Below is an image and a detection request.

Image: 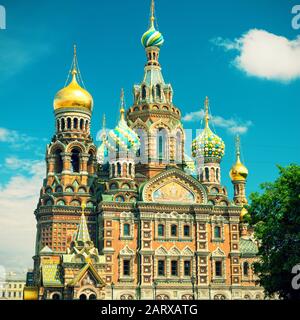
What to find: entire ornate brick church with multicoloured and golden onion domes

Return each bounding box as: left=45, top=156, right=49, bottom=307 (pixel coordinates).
left=25, top=1, right=263, bottom=300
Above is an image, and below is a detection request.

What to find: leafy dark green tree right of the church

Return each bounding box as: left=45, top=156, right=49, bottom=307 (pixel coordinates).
left=248, top=164, right=300, bottom=299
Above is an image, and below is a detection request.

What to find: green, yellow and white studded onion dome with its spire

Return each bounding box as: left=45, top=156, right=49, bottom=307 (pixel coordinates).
left=192, top=97, right=225, bottom=161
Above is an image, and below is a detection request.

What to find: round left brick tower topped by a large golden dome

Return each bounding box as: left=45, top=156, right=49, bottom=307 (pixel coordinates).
left=35, top=46, right=97, bottom=256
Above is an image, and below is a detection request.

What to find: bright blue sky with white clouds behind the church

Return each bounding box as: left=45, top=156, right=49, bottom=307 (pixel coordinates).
left=0, top=0, right=300, bottom=268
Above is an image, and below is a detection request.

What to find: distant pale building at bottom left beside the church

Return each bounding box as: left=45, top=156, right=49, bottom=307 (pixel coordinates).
left=0, top=274, right=25, bottom=300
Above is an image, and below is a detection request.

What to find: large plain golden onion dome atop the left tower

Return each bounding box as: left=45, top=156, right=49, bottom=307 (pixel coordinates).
left=53, top=68, right=93, bottom=111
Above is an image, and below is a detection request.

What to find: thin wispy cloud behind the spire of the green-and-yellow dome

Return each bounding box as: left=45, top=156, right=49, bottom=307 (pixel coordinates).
left=182, top=109, right=252, bottom=134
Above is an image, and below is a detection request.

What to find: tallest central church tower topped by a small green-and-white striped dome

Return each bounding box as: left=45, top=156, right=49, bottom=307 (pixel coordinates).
left=127, top=0, right=184, bottom=178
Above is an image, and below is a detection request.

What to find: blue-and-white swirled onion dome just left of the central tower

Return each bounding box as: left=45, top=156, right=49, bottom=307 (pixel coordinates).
left=107, top=90, right=140, bottom=152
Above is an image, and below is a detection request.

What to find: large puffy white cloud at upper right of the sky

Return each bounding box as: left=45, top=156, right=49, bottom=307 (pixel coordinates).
left=212, top=29, right=300, bottom=82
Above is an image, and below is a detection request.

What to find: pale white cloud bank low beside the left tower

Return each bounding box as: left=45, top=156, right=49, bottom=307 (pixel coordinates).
left=0, top=158, right=45, bottom=269
